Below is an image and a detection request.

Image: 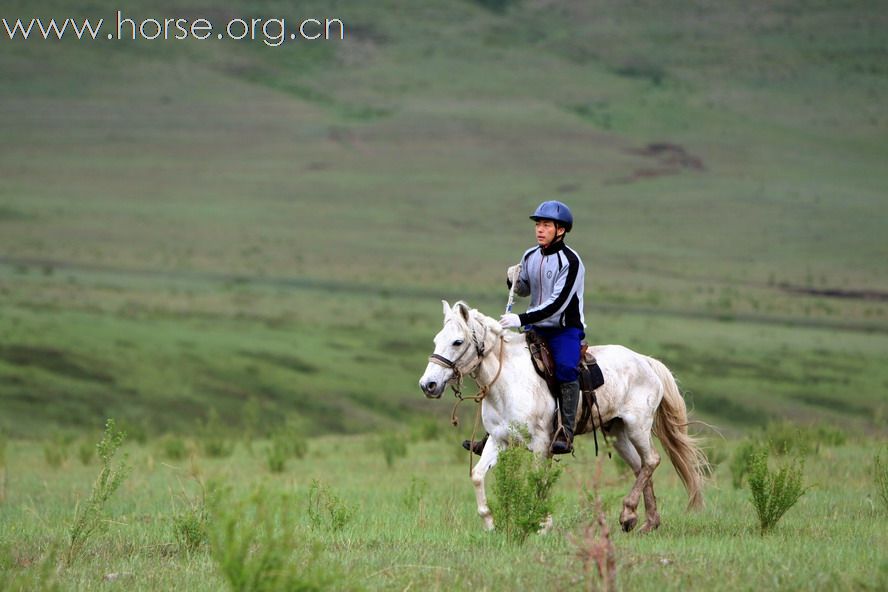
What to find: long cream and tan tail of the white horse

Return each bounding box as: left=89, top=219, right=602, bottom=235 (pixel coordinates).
left=648, top=357, right=709, bottom=510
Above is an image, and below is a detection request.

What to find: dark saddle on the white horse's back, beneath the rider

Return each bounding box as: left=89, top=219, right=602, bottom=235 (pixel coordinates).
left=525, top=331, right=604, bottom=442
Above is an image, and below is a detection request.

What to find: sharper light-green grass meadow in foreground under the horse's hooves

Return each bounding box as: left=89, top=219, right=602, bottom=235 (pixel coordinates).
left=0, top=434, right=888, bottom=590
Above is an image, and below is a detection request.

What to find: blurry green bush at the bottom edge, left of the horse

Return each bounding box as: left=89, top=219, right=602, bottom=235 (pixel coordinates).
left=209, top=489, right=349, bottom=592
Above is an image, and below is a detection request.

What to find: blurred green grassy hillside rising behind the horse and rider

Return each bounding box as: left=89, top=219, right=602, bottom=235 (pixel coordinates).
left=0, top=0, right=888, bottom=435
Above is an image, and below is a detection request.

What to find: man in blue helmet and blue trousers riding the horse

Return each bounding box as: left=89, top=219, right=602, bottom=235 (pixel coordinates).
left=463, top=201, right=586, bottom=454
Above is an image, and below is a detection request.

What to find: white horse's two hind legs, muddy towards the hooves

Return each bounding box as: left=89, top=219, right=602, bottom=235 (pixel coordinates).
left=618, top=418, right=660, bottom=532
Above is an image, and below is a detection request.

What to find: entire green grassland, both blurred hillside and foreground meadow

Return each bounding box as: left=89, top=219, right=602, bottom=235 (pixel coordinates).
left=0, top=0, right=888, bottom=590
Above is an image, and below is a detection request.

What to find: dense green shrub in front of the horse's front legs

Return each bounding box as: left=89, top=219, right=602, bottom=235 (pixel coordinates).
left=491, top=438, right=561, bottom=544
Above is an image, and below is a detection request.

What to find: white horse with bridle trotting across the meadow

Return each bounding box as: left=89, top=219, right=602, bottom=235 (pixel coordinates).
left=419, top=301, right=708, bottom=532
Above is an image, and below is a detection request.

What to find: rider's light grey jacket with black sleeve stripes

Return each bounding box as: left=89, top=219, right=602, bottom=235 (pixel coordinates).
left=506, top=241, right=586, bottom=330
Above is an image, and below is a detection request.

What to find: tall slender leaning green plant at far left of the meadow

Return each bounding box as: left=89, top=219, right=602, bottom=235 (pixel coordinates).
left=65, top=419, right=130, bottom=565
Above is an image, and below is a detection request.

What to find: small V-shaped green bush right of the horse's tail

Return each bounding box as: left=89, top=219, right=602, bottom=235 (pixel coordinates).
left=749, top=448, right=807, bottom=535
